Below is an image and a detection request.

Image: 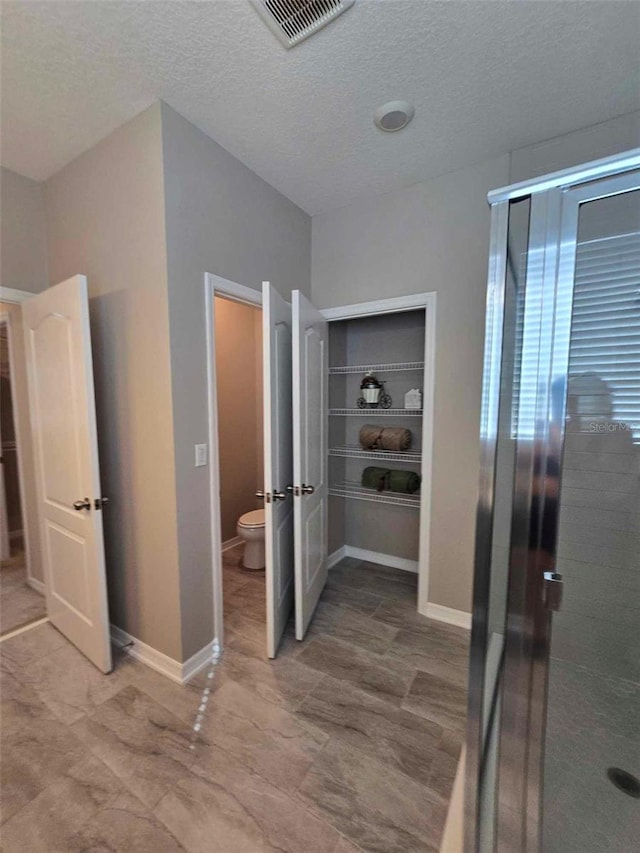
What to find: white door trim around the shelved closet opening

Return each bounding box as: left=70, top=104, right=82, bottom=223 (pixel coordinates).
left=320, top=291, right=437, bottom=616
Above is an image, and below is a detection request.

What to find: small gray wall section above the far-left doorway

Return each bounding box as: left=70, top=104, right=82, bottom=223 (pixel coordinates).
left=0, top=167, right=47, bottom=293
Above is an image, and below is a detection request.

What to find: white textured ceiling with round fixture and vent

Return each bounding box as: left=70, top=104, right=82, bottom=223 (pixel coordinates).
left=1, top=0, right=640, bottom=214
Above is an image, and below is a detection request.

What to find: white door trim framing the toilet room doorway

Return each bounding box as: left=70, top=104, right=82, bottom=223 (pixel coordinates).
left=204, top=272, right=262, bottom=649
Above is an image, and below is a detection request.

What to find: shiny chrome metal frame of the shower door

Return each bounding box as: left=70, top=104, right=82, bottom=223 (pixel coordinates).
left=465, top=149, right=640, bottom=853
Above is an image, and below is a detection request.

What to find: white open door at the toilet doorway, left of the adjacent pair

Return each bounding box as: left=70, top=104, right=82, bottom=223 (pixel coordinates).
left=262, top=282, right=293, bottom=658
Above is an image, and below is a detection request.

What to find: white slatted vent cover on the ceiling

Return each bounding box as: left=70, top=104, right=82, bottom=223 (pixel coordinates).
left=250, top=0, right=356, bottom=47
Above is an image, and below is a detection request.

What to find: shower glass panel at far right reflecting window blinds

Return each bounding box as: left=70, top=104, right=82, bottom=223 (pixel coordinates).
left=542, top=191, right=640, bottom=853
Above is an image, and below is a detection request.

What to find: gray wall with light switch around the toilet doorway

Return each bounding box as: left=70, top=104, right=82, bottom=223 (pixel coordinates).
left=162, top=104, right=311, bottom=657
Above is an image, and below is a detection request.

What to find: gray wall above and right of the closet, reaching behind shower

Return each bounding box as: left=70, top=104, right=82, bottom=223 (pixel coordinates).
left=311, top=113, right=640, bottom=610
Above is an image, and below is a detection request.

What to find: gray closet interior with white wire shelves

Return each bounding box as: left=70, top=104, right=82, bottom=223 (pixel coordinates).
left=328, top=311, right=425, bottom=565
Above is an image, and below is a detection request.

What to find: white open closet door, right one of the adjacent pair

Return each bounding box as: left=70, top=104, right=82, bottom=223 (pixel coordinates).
left=292, top=290, right=329, bottom=640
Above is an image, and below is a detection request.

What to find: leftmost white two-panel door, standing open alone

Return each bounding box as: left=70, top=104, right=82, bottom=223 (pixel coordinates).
left=22, top=275, right=111, bottom=672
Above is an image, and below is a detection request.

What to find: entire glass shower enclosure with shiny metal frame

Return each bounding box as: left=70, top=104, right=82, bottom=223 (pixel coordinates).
left=465, top=150, right=640, bottom=853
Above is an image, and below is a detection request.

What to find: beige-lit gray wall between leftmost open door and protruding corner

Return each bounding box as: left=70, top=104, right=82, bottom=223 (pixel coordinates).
left=45, top=104, right=184, bottom=660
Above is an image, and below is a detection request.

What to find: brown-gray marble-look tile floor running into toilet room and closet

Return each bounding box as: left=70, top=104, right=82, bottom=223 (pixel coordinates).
left=0, top=550, right=467, bottom=853
